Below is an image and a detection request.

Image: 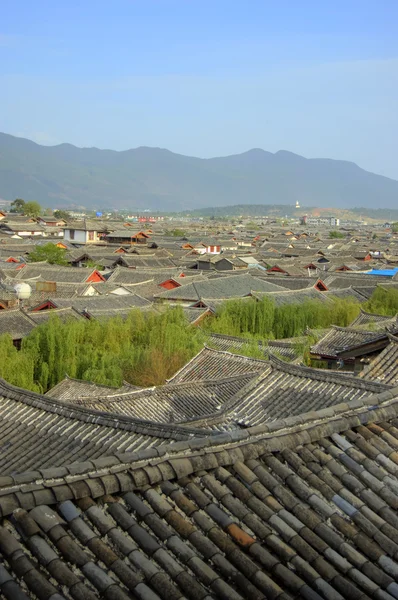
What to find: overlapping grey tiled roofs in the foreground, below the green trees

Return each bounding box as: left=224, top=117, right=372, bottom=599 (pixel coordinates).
left=0, top=336, right=398, bottom=600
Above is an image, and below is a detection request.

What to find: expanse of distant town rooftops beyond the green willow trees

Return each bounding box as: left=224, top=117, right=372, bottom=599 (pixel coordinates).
left=0, top=215, right=398, bottom=343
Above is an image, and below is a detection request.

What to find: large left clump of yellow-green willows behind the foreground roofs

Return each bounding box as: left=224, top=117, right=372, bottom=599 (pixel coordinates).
left=0, top=308, right=204, bottom=392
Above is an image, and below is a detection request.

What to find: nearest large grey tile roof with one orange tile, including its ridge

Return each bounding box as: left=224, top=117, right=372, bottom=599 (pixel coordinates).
left=0, top=390, right=398, bottom=600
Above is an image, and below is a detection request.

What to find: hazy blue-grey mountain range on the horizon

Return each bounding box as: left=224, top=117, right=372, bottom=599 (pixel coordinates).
left=0, top=133, right=398, bottom=212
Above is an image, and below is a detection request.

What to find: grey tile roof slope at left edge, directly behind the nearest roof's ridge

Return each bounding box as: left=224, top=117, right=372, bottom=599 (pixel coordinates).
left=0, top=380, right=211, bottom=474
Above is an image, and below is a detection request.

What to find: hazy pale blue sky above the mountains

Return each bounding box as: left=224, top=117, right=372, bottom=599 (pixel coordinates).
left=0, top=0, right=398, bottom=179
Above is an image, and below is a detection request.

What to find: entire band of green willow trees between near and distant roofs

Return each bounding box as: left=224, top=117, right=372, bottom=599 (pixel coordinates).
left=0, top=287, right=398, bottom=392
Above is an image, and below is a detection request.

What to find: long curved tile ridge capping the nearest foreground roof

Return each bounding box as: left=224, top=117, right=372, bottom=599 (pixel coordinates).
left=0, top=387, right=398, bottom=516
